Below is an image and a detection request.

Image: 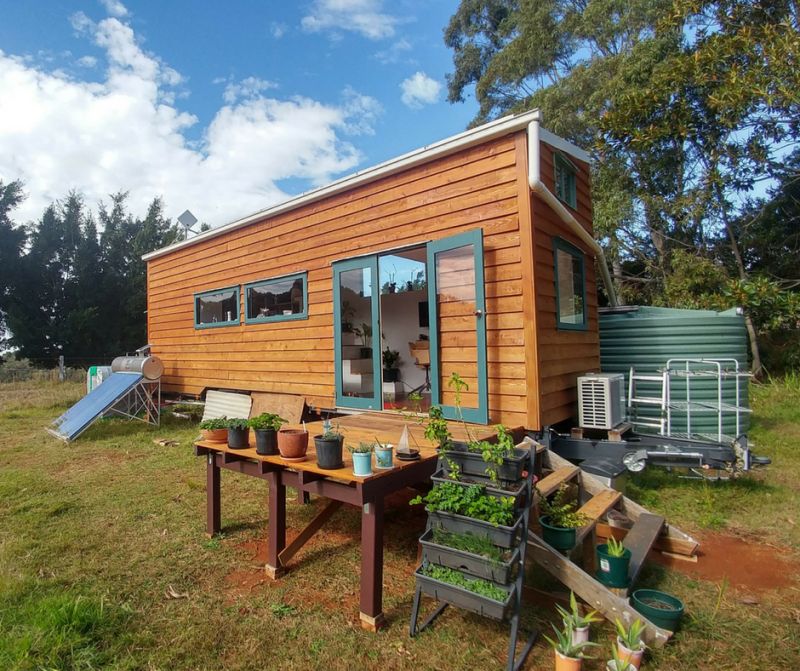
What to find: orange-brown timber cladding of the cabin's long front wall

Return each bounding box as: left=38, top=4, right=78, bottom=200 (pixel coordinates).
left=148, top=135, right=535, bottom=425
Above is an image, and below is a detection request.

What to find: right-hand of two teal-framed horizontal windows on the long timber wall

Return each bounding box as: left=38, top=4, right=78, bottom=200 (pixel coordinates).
left=244, top=273, right=308, bottom=323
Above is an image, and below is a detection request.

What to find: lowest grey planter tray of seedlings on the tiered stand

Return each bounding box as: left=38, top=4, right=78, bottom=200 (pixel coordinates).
left=414, top=564, right=516, bottom=620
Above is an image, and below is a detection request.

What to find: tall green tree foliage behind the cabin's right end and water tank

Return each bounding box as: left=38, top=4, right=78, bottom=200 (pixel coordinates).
left=445, top=0, right=800, bottom=371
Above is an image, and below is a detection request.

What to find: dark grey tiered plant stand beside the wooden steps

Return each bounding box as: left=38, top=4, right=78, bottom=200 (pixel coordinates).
left=409, top=440, right=537, bottom=671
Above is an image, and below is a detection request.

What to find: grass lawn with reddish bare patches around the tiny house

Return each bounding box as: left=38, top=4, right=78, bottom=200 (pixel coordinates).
left=0, top=383, right=800, bottom=671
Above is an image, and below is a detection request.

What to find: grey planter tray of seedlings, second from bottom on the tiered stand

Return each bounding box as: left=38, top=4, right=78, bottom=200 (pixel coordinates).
left=419, top=527, right=519, bottom=585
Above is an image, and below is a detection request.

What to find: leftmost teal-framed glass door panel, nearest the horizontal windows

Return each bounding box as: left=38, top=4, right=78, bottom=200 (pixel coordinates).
left=333, top=256, right=381, bottom=410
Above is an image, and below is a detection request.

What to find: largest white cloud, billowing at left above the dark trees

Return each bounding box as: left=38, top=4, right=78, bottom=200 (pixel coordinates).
left=0, top=18, right=380, bottom=225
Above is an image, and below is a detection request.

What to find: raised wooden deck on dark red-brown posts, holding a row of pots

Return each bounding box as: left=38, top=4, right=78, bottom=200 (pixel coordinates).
left=195, top=413, right=494, bottom=631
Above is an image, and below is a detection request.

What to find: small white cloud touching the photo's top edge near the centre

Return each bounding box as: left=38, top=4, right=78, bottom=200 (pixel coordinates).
left=301, top=0, right=400, bottom=40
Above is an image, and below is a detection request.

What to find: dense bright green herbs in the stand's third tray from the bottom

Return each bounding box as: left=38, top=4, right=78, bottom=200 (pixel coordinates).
left=409, top=482, right=514, bottom=526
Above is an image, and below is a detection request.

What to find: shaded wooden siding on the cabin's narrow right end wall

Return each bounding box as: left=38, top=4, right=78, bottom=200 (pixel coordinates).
left=528, top=143, right=600, bottom=429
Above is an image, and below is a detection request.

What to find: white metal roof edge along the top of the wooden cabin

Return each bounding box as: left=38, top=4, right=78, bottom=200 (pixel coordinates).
left=142, top=110, right=589, bottom=261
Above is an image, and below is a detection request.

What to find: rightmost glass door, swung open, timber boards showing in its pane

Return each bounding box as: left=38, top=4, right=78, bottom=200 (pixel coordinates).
left=428, top=230, right=489, bottom=423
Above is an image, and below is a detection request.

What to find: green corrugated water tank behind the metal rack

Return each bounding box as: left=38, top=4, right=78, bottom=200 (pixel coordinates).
left=600, top=306, right=750, bottom=439
